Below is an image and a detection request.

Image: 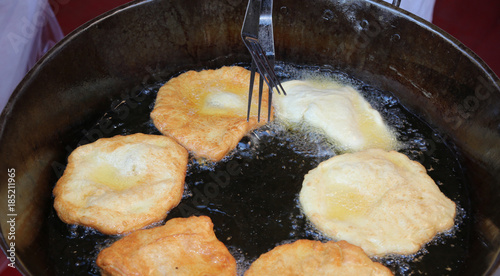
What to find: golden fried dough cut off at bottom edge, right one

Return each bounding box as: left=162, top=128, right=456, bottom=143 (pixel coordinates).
left=245, top=240, right=392, bottom=276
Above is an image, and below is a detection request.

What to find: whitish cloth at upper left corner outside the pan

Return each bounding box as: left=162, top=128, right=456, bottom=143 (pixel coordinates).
left=0, top=0, right=63, bottom=111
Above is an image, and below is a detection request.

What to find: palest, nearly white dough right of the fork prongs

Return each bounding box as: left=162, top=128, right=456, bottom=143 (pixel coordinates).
left=274, top=80, right=398, bottom=151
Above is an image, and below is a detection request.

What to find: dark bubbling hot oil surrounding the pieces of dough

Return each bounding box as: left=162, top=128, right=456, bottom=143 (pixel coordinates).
left=45, top=64, right=470, bottom=275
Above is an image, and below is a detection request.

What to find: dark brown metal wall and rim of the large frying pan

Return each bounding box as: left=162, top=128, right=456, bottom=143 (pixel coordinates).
left=0, top=0, right=500, bottom=275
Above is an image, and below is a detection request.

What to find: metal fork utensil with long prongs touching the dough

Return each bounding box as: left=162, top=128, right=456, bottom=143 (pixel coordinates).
left=241, top=0, right=286, bottom=122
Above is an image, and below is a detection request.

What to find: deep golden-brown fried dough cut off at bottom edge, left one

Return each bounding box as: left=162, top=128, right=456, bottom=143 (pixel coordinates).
left=97, top=216, right=236, bottom=276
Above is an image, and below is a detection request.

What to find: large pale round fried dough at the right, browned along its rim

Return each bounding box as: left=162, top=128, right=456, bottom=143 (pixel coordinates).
left=300, top=149, right=456, bottom=256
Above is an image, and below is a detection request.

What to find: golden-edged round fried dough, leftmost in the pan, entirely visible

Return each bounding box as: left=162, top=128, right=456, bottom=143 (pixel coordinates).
left=53, top=134, right=188, bottom=235
